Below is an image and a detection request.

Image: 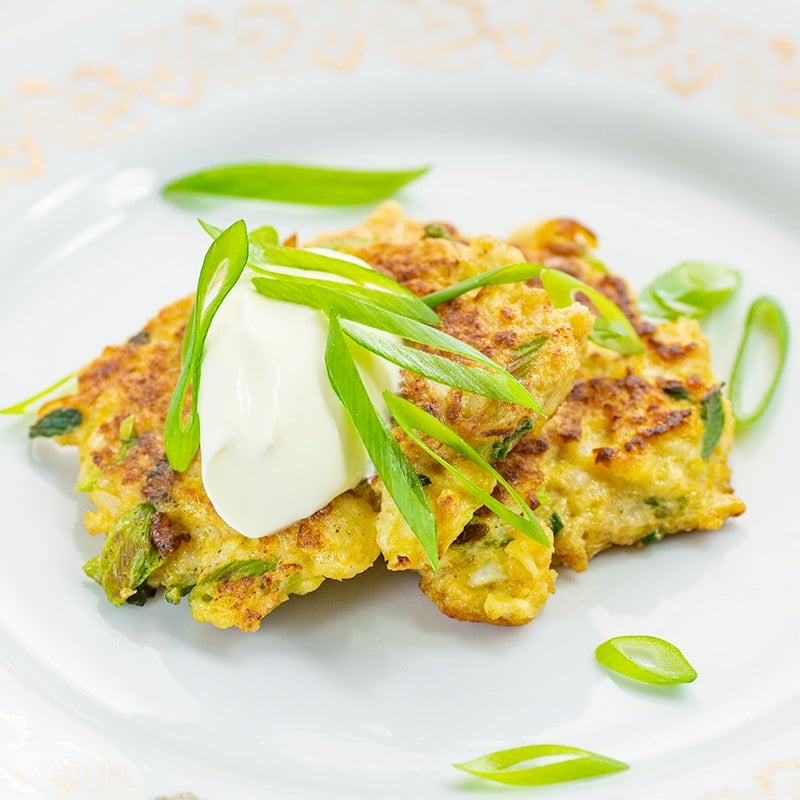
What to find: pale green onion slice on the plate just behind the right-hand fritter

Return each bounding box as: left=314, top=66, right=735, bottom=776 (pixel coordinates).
left=639, top=261, right=741, bottom=320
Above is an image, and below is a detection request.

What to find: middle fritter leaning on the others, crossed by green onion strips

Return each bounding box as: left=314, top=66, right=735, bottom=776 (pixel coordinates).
left=315, top=203, right=593, bottom=580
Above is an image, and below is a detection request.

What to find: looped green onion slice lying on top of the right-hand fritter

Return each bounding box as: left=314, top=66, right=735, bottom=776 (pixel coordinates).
left=539, top=269, right=644, bottom=356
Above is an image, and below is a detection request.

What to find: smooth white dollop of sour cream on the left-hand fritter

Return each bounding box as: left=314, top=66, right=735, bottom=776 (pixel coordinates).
left=198, top=251, right=399, bottom=538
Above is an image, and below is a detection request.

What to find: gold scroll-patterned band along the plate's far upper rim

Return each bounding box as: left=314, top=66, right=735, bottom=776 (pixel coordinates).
left=0, top=0, right=800, bottom=188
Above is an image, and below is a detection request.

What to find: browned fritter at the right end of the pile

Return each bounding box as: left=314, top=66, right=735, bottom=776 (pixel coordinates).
left=511, top=220, right=744, bottom=570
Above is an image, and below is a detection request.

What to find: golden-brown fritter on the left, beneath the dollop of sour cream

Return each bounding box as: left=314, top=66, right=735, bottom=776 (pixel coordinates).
left=41, top=298, right=378, bottom=630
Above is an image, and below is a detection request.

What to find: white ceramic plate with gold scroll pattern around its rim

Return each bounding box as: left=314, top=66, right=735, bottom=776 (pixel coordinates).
left=0, top=0, right=800, bottom=800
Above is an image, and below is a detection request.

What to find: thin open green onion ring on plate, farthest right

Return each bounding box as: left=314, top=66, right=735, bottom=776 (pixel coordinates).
left=728, top=297, right=789, bottom=425
